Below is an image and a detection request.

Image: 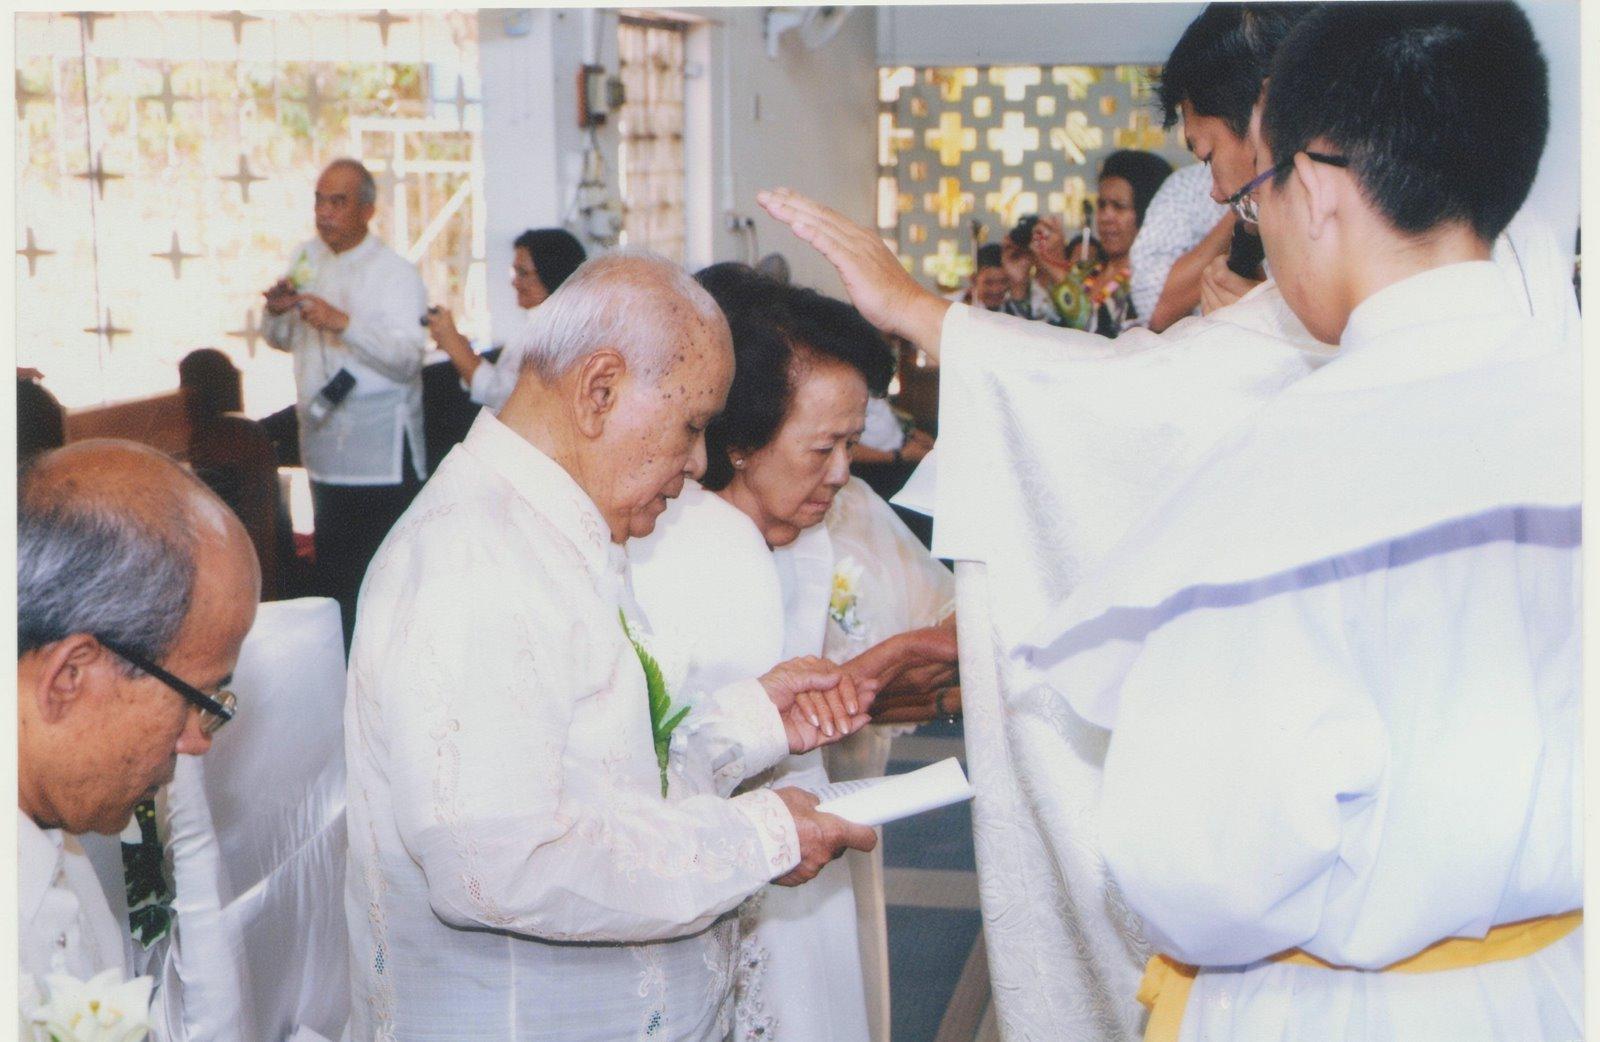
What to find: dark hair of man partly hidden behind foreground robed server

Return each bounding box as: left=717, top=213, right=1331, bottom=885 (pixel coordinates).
left=1157, top=3, right=1314, bottom=138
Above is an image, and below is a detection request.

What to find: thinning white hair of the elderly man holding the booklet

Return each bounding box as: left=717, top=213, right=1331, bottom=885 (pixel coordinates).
left=507, top=250, right=731, bottom=381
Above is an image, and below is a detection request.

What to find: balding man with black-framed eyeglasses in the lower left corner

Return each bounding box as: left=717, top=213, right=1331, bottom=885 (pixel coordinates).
left=16, top=440, right=261, bottom=1024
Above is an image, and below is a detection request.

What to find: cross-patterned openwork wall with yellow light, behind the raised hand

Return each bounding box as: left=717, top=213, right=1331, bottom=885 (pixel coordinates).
left=878, top=66, right=1194, bottom=288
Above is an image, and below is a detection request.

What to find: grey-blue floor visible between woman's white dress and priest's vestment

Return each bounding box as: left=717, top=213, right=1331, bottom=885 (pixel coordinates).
left=883, top=723, right=994, bottom=1042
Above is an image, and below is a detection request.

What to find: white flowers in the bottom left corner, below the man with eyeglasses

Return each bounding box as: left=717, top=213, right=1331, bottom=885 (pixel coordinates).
left=21, top=970, right=155, bottom=1042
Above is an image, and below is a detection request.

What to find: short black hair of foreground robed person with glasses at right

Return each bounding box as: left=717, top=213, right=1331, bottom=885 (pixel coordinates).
left=1261, top=0, right=1550, bottom=242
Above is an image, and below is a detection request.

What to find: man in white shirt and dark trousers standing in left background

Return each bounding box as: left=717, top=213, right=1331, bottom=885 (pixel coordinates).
left=264, top=158, right=427, bottom=642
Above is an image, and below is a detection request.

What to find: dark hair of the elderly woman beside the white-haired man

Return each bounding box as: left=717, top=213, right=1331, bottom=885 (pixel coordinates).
left=694, top=264, right=894, bottom=491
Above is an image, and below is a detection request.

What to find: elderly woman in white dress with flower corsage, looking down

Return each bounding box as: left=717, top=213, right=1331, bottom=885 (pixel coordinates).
left=629, top=266, right=958, bottom=1042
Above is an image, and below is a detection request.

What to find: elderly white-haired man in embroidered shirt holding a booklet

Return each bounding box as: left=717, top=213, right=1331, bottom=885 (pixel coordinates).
left=346, top=254, right=875, bottom=1042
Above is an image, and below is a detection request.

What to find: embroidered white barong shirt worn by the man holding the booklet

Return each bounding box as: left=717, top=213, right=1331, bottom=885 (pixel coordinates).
left=346, top=411, right=798, bottom=1042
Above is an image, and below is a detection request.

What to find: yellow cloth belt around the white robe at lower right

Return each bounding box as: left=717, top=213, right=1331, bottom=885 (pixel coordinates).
left=1139, top=908, right=1584, bottom=1042
